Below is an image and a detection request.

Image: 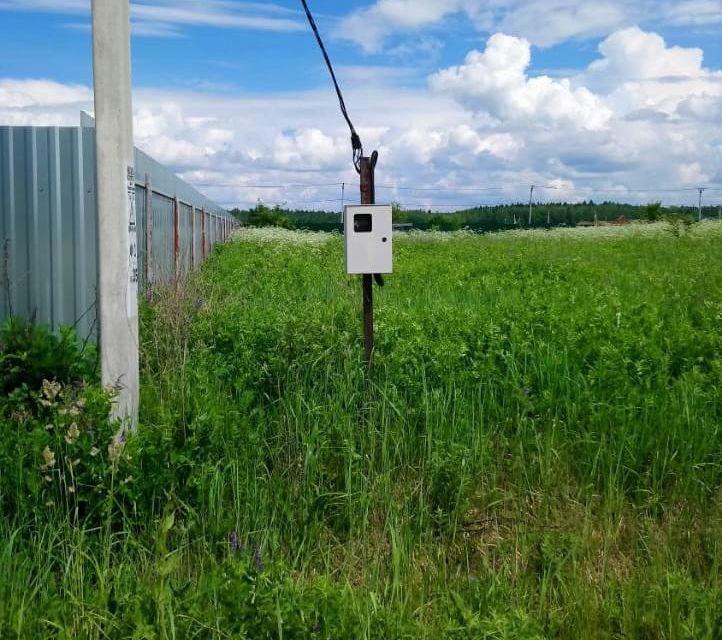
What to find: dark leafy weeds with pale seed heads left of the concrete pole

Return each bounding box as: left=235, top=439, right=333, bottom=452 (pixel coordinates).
left=0, top=320, right=130, bottom=522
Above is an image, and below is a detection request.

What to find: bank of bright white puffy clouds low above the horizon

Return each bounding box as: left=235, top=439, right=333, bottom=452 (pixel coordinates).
left=0, top=27, right=722, bottom=209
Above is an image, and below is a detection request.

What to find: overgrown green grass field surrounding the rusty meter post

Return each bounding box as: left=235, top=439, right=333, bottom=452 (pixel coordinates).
left=0, top=223, right=722, bottom=640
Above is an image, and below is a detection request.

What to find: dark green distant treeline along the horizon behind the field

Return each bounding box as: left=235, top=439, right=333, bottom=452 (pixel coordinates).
left=231, top=201, right=718, bottom=231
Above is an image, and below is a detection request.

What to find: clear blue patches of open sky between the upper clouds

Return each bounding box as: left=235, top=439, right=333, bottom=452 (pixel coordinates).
left=5, top=0, right=722, bottom=93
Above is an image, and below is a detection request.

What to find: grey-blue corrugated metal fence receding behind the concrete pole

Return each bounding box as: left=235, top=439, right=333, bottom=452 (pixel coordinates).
left=0, top=122, right=236, bottom=338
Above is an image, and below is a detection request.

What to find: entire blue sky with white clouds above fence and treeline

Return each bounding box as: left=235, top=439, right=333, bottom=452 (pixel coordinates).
left=0, top=0, right=722, bottom=210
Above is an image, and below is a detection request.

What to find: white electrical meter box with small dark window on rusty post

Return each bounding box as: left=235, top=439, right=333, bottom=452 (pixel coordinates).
left=344, top=204, right=393, bottom=273
